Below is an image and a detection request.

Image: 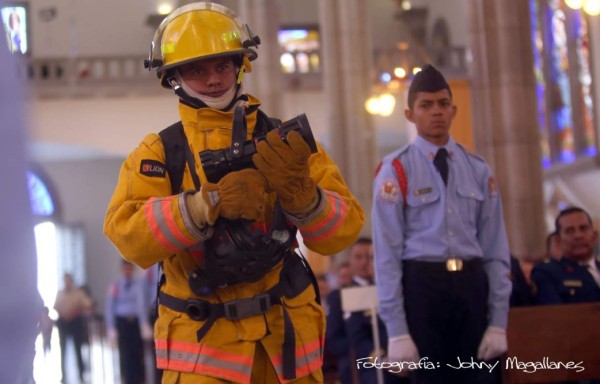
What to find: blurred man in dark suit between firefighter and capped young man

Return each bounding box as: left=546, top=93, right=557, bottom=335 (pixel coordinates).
left=325, top=237, right=405, bottom=384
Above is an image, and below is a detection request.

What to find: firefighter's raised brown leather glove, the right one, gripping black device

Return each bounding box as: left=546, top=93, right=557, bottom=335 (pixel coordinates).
left=252, top=131, right=319, bottom=216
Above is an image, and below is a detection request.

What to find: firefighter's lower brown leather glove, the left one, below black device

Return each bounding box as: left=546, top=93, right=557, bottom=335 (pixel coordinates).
left=186, top=169, right=267, bottom=228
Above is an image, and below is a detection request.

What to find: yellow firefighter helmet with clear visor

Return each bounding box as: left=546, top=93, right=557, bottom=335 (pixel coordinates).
left=144, top=2, right=260, bottom=88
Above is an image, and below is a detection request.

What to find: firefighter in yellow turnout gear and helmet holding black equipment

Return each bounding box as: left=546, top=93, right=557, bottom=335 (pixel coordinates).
left=104, top=3, right=364, bottom=384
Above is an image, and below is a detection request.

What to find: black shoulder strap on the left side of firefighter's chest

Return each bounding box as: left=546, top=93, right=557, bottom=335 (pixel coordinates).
left=159, top=121, right=200, bottom=194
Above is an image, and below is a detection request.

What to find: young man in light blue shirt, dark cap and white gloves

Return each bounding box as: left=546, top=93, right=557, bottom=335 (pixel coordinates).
left=372, top=65, right=511, bottom=383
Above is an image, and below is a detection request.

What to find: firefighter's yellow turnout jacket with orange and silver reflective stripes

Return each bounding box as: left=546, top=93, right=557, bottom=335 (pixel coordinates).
left=104, top=96, right=364, bottom=383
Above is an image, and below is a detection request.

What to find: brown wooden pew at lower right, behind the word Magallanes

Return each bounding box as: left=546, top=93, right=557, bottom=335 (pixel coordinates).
left=502, top=302, right=600, bottom=384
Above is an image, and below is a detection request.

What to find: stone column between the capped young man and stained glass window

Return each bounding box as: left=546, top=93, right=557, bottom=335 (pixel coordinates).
left=467, top=0, right=546, bottom=258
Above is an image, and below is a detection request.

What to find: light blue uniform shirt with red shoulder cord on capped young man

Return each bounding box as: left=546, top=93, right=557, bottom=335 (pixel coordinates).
left=372, top=136, right=512, bottom=337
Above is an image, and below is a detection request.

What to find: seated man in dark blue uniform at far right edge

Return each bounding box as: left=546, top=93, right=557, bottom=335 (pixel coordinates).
left=531, top=207, right=600, bottom=304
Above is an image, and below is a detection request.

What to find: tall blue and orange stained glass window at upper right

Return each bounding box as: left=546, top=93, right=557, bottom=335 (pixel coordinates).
left=529, top=0, right=597, bottom=168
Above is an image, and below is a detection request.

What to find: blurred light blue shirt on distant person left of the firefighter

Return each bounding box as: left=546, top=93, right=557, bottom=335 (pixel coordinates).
left=104, top=277, right=148, bottom=329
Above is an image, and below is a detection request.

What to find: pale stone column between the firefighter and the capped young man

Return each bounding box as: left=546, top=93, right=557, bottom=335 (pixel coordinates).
left=319, top=0, right=376, bottom=234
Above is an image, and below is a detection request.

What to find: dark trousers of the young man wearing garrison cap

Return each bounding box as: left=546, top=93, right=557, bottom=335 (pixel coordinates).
left=402, top=258, right=488, bottom=384
